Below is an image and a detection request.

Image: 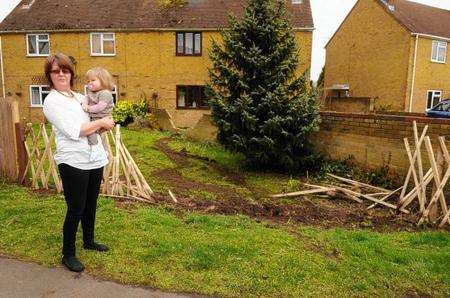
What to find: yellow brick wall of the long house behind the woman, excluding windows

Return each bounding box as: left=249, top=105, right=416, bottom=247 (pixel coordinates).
left=2, top=31, right=312, bottom=127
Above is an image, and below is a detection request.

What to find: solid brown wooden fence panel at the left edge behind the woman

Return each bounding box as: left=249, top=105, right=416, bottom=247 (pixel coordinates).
left=0, top=98, right=27, bottom=181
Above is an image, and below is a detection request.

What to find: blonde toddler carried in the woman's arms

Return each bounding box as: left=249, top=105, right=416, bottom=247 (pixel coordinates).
left=82, top=67, right=114, bottom=145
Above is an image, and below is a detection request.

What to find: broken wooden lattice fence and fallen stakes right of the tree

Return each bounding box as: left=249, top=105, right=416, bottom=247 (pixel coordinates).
left=272, top=122, right=450, bottom=227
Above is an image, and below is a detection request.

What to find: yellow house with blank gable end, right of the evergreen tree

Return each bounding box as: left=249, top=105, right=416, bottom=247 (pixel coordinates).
left=324, top=0, right=450, bottom=113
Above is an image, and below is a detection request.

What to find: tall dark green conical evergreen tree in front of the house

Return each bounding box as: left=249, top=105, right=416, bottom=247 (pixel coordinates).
left=206, top=0, right=320, bottom=170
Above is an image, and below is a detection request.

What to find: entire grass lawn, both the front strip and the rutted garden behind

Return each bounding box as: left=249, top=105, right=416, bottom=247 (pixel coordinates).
left=0, top=129, right=450, bottom=297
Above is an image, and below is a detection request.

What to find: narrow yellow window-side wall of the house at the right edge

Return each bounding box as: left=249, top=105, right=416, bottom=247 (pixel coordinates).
left=412, top=37, right=450, bottom=113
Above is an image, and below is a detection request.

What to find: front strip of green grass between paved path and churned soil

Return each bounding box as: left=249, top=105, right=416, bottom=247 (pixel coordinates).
left=0, top=184, right=450, bottom=297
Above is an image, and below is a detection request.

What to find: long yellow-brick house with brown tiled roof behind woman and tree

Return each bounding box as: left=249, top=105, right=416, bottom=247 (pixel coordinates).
left=0, top=0, right=314, bottom=127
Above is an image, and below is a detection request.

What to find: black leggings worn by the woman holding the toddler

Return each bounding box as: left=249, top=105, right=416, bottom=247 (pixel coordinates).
left=58, top=163, right=103, bottom=257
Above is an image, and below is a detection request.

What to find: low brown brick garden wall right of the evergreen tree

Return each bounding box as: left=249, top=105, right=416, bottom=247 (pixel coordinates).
left=314, top=112, right=450, bottom=173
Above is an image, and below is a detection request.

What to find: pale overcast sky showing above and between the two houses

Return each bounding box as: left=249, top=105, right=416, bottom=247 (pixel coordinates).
left=0, top=0, right=450, bottom=80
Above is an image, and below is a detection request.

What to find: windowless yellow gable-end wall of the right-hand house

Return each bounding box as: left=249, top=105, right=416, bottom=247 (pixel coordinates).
left=325, top=0, right=411, bottom=111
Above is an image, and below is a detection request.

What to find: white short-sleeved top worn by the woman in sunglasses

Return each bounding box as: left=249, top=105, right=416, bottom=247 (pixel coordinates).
left=44, top=90, right=108, bottom=170
